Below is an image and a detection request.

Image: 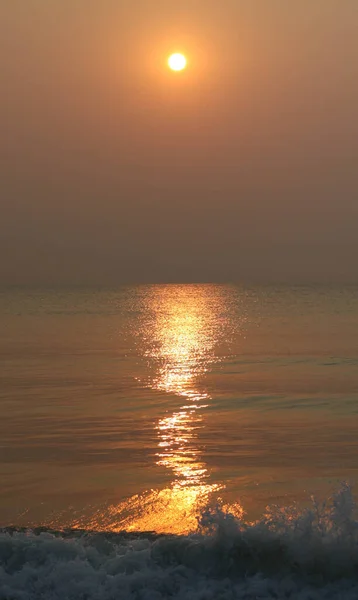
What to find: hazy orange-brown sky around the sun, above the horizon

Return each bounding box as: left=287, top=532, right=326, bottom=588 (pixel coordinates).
left=0, top=0, right=358, bottom=284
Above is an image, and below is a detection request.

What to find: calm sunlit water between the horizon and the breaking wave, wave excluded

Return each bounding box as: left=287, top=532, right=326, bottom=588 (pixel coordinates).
left=0, top=285, right=358, bottom=533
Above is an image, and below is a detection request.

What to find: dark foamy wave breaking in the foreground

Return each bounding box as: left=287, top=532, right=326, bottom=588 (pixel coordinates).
left=0, top=484, right=358, bottom=600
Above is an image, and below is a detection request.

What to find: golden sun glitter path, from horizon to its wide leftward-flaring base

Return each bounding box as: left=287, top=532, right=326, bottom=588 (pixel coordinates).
left=47, top=285, right=243, bottom=534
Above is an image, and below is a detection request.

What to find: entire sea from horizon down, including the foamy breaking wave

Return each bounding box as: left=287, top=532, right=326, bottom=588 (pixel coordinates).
left=0, top=284, right=358, bottom=600
